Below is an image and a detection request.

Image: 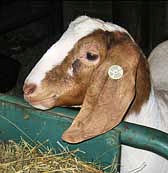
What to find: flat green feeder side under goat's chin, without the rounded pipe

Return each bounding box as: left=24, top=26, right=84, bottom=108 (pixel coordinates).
left=0, top=95, right=120, bottom=173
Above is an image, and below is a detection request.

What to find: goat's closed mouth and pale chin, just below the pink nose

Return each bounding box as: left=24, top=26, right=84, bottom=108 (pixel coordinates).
left=24, top=95, right=57, bottom=110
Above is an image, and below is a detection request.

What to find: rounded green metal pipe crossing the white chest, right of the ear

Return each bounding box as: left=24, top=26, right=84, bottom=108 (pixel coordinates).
left=115, top=122, right=168, bottom=159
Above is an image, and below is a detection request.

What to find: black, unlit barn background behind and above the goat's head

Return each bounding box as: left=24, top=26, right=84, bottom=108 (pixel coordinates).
left=0, top=0, right=168, bottom=96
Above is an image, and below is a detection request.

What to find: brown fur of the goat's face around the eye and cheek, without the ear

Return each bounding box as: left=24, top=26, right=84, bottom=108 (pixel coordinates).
left=37, top=31, right=107, bottom=107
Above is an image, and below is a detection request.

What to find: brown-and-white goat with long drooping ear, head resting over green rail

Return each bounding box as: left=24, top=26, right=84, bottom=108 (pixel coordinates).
left=23, top=16, right=168, bottom=173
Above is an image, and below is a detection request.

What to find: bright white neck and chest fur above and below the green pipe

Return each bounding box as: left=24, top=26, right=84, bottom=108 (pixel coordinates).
left=121, top=88, right=168, bottom=173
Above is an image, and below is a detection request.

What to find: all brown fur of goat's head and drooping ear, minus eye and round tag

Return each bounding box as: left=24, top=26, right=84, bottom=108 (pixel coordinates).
left=24, top=30, right=150, bottom=143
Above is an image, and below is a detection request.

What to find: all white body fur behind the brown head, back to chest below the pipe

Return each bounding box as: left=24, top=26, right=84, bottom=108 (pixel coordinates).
left=121, top=41, right=168, bottom=173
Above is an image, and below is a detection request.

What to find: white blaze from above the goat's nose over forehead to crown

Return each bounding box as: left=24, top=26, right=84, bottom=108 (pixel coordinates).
left=26, top=16, right=127, bottom=85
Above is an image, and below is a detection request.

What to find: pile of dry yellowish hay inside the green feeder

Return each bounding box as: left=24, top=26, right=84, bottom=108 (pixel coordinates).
left=0, top=139, right=103, bottom=173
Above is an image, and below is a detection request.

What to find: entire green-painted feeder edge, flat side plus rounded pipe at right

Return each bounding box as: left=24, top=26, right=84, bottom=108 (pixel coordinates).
left=0, top=95, right=168, bottom=172
